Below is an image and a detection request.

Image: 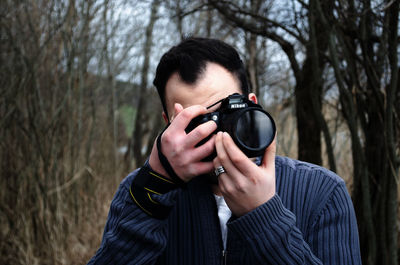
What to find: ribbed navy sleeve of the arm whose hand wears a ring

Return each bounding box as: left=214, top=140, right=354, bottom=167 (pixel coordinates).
left=228, top=161, right=361, bottom=264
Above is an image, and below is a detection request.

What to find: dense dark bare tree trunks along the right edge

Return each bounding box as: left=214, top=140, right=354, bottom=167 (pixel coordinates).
left=317, top=1, right=400, bottom=264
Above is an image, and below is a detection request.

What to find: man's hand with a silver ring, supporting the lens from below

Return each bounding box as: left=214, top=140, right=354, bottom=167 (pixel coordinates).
left=213, top=132, right=276, bottom=216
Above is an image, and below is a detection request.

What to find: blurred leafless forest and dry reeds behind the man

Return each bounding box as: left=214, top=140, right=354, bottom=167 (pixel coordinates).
left=0, top=0, right=400, bottom=265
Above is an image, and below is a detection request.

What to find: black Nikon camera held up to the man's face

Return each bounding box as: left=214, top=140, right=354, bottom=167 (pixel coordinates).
left=185, top=93, right=276, bottom=158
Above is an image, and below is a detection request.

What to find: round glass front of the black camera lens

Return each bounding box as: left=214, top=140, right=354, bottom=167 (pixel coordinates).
left=235, top=109, right=275, bottom=155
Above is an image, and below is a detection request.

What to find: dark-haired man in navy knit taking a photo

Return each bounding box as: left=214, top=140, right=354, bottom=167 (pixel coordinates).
left=89, top=38, right=361, bottom=265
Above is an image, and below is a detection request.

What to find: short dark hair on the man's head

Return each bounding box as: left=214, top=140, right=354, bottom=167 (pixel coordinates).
left=153, top=37, right=249, bottom=117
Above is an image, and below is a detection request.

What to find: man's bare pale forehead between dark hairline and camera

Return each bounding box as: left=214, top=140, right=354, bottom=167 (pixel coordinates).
left=165, top=63, right=241, bottom=117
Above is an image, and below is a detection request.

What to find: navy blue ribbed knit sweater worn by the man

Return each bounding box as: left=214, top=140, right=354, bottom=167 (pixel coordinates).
left=89, top=157, right=361, bottom=265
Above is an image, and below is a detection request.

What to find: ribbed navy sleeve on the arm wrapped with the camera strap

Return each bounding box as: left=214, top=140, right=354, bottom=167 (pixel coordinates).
left=88, top=170, right=177, bottom=265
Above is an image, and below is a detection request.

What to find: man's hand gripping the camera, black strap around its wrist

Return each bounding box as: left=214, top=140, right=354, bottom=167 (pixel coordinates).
left=149, top=103, right=217, bottom=182
